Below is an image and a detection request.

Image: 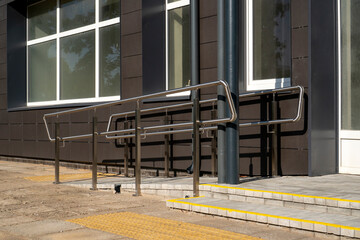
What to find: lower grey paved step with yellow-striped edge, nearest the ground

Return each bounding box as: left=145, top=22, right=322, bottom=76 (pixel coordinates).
left=166, top=197, right=360, bottom=238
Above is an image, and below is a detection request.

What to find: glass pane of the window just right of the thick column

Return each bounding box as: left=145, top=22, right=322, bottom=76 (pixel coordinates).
left=253, top=0, right=291, bottom=80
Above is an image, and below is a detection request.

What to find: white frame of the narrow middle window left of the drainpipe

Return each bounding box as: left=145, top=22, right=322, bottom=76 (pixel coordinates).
left=165, top=0, right=190, bottom=97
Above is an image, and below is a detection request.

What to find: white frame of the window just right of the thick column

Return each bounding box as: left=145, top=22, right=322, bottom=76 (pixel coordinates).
left=245, top=0, right=291, bottom=91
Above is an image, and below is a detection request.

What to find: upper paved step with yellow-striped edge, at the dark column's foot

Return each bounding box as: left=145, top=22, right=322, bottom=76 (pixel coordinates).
left=200, top=184, right=360, bottom=217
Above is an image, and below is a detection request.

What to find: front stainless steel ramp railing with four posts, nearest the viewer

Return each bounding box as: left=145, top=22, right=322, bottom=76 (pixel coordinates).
left=43, top=80, right=237, bottom=196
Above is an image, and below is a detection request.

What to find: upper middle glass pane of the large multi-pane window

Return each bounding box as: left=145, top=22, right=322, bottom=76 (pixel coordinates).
left=60, top=0, right=95, bottom=32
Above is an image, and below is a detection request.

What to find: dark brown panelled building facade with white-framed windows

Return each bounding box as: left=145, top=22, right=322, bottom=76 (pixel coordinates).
left=0, top=0, right=352, bottom=176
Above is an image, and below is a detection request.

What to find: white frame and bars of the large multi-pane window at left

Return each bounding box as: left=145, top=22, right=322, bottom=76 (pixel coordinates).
left=26, top=0, right=120, bottom=107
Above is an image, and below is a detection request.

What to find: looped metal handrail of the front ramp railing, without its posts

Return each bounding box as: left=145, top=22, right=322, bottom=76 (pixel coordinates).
left=43, top=80, right=237, bottom=142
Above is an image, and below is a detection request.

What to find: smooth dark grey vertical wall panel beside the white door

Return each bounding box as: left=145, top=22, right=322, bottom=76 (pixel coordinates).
left=309, top=0, right=338, bottom=176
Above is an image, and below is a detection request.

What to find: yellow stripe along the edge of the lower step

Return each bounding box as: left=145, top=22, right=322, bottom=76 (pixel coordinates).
left=168, top=198, right=360, bottom=231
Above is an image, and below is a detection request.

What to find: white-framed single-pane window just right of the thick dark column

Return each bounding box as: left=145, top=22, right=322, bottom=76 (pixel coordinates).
left=246, top=0, right=291, bottom=90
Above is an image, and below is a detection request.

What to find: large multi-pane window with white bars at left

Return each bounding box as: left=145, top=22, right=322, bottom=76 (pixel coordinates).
left=27, top=0, right=120, bottom=106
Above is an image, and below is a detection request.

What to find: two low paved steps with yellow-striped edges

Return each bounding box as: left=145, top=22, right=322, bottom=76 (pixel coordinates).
left=167, top=184, right=360, bottom=238
